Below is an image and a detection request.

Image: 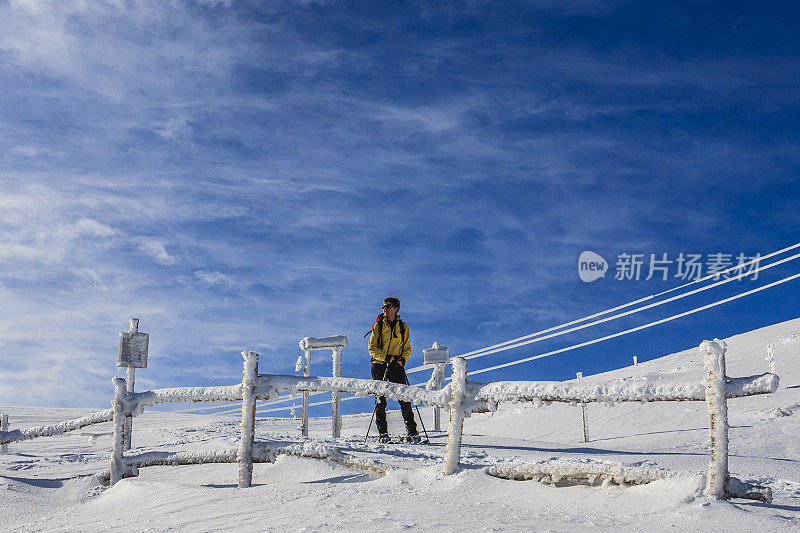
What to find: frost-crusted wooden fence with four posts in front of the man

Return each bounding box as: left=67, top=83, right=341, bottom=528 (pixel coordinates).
left=100, top=340, right=779, bottom=500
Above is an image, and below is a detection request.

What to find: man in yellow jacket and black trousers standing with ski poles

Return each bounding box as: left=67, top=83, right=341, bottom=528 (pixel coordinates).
left=369, top=296, right=420, bottom=442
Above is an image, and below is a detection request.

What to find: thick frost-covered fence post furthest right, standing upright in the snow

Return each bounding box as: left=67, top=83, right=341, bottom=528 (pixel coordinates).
left=700, top=339, right=729, bottom=499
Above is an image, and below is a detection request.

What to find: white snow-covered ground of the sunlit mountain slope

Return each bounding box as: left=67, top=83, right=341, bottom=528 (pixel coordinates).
left=0, top=319, right=800, bottom=531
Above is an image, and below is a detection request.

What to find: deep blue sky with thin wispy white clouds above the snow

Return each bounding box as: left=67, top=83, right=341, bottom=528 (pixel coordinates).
left=0, top=0, right=800, bottom=407
